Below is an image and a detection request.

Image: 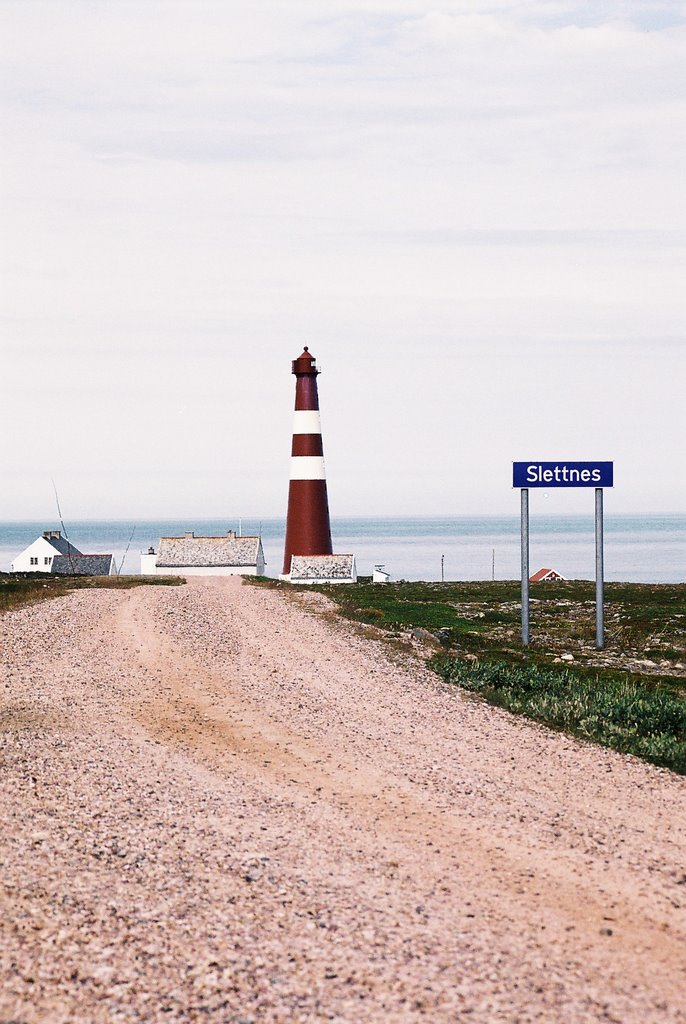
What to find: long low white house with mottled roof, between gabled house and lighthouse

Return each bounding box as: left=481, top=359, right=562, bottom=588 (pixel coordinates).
left=140, top=529, right=265, bottom=575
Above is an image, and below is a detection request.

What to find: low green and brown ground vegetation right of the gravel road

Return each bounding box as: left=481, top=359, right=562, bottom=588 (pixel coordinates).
left=303, top=581, right=686, bottom=774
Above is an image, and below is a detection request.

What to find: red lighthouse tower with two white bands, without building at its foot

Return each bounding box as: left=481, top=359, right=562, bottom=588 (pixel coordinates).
left=284, top=346, right=333, bottom=575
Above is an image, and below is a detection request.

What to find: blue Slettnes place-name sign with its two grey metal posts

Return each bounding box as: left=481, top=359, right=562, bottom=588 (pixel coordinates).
left=512, top=462, right=614, bottom=650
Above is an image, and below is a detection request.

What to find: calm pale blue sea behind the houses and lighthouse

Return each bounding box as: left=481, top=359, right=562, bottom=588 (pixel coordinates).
left=0, top=512, right=686, bottom=583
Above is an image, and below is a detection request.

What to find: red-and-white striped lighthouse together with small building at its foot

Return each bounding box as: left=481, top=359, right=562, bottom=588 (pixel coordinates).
left=282, top=346, right=356, bottom=583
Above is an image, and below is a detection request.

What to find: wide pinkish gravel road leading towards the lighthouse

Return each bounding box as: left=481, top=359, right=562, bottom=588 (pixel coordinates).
left=0, top=578, right=686, bottom=1024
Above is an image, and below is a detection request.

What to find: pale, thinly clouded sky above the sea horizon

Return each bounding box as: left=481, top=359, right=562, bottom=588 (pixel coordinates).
left=0, top=0, right=686, bottom=521
